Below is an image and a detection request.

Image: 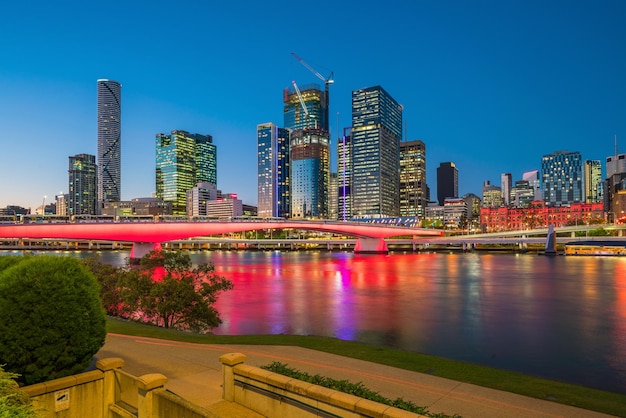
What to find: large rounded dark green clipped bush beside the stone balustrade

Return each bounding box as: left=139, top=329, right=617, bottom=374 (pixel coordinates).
left=0, top=256, right=106, bottom=384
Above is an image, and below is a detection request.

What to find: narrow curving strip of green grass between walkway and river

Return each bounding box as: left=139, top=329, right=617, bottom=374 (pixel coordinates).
left=107, top=318, right=626, bottom=417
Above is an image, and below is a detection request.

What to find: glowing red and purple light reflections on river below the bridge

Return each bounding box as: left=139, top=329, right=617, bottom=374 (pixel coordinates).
left=212, top=253, right=444, bottom=339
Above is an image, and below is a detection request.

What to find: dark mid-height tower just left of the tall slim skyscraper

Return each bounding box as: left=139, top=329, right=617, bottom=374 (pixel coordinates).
left=67, top=154, right=99, bottom=216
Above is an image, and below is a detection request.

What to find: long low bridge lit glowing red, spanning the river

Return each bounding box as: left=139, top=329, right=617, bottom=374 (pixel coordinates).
left=0, top=220, right=443, bottom=258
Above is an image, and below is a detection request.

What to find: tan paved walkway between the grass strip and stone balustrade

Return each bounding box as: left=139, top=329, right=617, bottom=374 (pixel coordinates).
left=96, top=334, right=609, bottom=418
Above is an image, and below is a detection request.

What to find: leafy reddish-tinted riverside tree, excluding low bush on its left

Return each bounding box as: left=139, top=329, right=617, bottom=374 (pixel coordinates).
left=120, top=251, right=233, bottom=332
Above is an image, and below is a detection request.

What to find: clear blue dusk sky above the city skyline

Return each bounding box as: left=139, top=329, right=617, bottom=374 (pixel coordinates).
left=0, top=0, right=626, bottom=210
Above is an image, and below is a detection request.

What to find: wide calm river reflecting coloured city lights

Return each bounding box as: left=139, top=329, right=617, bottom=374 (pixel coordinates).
left=2, top=251, right=626, bottom=393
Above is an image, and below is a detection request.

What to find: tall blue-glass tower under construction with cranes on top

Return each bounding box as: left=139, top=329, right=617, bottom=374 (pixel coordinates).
left=284, top=86, right=330, bottom=219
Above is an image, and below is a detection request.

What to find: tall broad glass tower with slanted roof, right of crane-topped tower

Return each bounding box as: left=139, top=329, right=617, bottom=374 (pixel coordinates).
left=351, top=86, right=402, bottom=218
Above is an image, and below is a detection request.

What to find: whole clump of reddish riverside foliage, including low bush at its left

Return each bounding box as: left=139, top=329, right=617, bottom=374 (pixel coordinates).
left=85, top=251, right=233, bottom=333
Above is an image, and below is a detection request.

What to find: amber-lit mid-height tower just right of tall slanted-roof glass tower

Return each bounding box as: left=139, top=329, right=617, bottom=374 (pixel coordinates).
left=400, top=140, right=430, bottom=219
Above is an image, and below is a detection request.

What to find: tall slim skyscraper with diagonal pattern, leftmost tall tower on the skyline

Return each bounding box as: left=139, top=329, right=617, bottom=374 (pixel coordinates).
left=97, top=79, right=122, bottom=207
